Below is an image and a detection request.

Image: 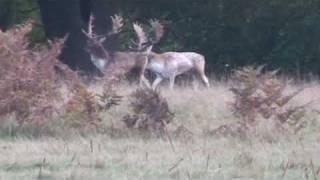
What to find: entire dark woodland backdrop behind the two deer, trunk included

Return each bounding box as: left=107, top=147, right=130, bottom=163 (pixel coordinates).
left=0, top=0, right=320, bottom=79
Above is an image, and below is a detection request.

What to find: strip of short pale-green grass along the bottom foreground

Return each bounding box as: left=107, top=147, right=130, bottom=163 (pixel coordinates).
left=0, top=134, right=320, bottom=180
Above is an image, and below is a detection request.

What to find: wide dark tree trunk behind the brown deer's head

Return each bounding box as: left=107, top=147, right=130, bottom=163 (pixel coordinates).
left=38, top=0, right=97, bottom=73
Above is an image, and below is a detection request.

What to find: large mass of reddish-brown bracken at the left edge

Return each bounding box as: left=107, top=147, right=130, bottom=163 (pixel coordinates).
left=0, top=23, right=120, bottom=132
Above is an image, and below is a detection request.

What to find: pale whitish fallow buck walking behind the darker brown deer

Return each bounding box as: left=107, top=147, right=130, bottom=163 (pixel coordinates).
left=136, top=20, right=209, bottom=89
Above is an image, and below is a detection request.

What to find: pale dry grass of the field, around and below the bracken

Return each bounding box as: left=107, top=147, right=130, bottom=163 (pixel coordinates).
left=0, top=82, right=320, bottom=180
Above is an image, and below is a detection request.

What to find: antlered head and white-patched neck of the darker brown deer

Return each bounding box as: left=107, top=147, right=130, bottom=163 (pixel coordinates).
left=82, top=15, right=123, bottom=72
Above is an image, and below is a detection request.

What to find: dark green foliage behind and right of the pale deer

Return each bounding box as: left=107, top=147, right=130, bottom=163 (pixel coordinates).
left=106, top=0, right=320, bottom=78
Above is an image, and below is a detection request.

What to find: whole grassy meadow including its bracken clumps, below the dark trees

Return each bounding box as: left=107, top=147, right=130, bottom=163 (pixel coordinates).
left=0, top=23, right=320, bottom=180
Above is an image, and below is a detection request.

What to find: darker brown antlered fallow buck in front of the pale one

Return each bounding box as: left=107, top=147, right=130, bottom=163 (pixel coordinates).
left=83, top=15, right=150, bottom=87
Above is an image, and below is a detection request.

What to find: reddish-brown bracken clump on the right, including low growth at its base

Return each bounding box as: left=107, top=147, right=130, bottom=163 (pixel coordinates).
left=214, top=66, right=311, bottom=137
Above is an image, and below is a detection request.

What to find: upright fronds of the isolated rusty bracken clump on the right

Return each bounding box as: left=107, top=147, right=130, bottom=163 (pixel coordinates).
left=231, top=66, right=307, bottom=130
